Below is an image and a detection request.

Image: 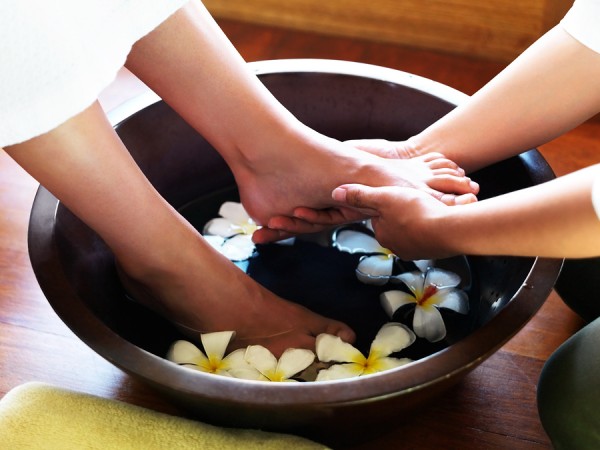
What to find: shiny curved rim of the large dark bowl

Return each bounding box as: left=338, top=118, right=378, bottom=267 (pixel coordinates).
left=28, top=59, right=562, bottom=407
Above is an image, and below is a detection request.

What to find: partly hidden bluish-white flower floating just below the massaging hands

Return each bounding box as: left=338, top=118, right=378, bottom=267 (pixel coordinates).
left=333, top=229, right=395, bottom=285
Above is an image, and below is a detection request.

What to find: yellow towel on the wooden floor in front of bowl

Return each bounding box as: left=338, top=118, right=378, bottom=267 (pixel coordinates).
left=0, top=383, right=326, bottom=450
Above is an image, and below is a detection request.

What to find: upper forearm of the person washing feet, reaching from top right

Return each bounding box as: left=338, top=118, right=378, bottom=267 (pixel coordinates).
left=409, top=27, right=600, bottom=171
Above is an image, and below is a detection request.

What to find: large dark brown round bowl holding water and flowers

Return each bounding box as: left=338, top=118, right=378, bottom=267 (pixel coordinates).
left=29, top=60, right=561, bottom=442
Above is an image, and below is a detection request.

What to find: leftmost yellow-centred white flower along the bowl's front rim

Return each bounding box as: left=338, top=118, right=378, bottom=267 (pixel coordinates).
left=167, top=331, right=261, bottom=380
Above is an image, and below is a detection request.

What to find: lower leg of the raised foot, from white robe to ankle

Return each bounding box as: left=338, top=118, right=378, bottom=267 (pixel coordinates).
left=127, top=2, right=301, bottom=166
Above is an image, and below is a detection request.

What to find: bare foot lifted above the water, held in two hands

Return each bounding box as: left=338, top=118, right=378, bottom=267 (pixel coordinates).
left=234, top=134, right=478, bottom=229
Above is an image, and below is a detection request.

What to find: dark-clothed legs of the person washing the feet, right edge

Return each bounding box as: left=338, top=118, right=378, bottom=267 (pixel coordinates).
left=538, top=258, right=600, bottom=449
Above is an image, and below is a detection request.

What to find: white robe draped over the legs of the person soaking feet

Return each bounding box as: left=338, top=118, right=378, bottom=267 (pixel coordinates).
left=0, top=0, right=186, bottom=147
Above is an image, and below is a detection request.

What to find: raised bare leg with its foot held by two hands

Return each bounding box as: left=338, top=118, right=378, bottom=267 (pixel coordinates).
left=127, top=2, right=474, bottom=223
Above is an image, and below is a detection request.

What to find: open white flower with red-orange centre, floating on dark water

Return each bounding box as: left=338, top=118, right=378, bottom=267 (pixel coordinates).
left=381, top=268, right=469, bottom=342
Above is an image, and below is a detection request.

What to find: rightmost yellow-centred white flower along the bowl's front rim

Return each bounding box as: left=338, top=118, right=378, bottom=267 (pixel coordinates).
left=316, top=322, right=416, bottom=381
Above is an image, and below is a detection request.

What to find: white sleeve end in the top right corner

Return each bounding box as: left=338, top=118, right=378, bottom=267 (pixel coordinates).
left=560, top=0, right=600, bottom=53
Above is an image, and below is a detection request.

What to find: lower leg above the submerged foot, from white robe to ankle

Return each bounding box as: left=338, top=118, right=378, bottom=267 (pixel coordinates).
left=5, top=102, right=197, bottom=264
